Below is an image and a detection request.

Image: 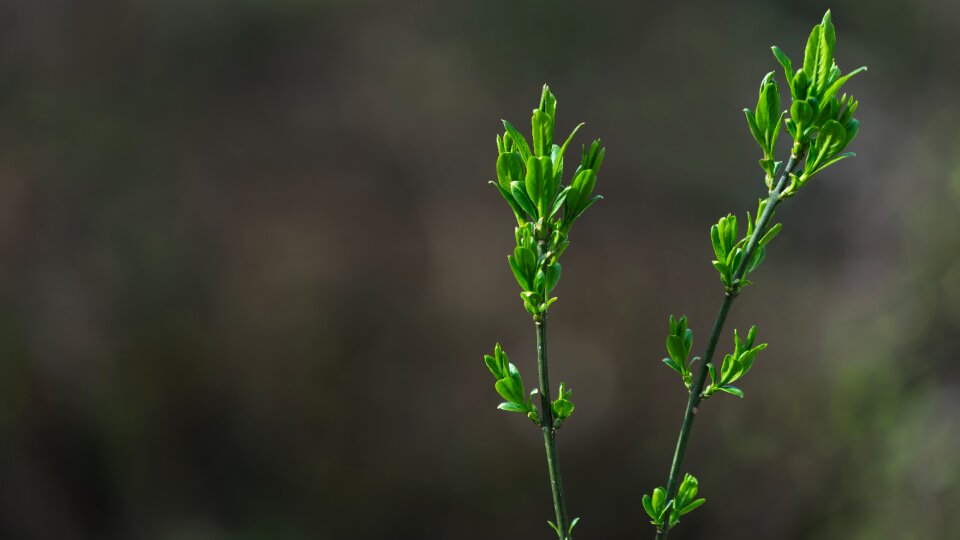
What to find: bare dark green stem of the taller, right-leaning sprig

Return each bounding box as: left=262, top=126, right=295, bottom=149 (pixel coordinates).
left=656, top=154, right=801, bottom=540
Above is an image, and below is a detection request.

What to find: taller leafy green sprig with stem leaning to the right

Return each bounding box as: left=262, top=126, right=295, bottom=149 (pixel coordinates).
left=643, top=11, right=867, bottom=539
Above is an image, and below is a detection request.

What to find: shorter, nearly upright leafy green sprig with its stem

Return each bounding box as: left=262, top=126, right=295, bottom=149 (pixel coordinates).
left=484, top=85, right=605, bottom=540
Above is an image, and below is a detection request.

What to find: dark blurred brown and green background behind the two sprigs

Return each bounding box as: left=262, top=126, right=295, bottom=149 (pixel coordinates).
left=0, top=0, right=960, bottom=540
